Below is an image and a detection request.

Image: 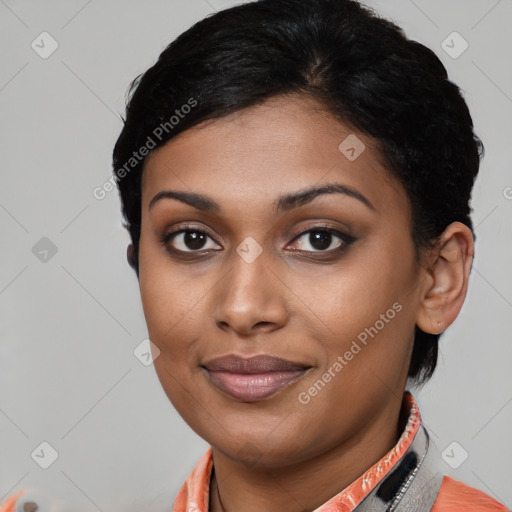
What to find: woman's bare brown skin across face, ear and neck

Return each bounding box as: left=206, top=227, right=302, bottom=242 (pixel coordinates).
left=133, top=95, right=473, bottom=512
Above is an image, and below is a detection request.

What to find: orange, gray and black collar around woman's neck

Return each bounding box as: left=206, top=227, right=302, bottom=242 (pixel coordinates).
left=173, top=391, right=441, bottom=512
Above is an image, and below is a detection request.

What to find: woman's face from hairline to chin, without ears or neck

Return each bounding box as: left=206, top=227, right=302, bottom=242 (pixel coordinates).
left=139, top=96, right=422, bottom=465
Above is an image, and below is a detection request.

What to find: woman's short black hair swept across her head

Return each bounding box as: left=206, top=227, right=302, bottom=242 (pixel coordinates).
left=113, top=0, right=484, bottom=386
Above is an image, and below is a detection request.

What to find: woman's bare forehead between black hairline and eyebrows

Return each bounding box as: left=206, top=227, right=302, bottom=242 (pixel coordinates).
left=142, top=96, right=407, bottom=216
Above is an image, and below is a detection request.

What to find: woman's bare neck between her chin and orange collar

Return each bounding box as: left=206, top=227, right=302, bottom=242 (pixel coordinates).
left=210, top=396, right=407, bottom=512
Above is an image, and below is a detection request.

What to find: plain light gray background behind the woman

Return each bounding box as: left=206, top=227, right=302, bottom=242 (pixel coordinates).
left=0, top=0, right=512, bottom=512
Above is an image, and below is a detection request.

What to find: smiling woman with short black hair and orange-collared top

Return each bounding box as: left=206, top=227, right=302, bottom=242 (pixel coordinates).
left=3, top=0, right=507, bottom=512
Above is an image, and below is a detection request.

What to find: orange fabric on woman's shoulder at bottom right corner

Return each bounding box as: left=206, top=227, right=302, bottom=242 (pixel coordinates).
left=431, top=475, right=510, bottom=512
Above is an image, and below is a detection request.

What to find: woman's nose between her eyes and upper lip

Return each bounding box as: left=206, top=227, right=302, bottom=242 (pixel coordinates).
left=214, top=243, right=290, bottom=336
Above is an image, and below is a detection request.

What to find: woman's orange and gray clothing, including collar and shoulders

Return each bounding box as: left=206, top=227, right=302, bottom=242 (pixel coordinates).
left=0, top=391, right=510, bottom=512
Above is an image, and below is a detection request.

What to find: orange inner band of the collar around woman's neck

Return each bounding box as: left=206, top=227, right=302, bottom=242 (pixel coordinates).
left=173, top=391, right=421, bottom=512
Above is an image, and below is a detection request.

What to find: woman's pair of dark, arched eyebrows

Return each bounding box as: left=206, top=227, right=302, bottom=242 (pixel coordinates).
left=148, top=183, right=375, bottom=214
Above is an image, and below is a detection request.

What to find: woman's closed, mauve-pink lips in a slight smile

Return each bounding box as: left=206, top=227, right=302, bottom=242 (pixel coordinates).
left=201, top=354, right=312, bottom=402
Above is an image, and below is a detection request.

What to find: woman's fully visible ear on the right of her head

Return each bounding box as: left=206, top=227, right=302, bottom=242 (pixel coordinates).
left=416, top=222, right=474, bottom=334
